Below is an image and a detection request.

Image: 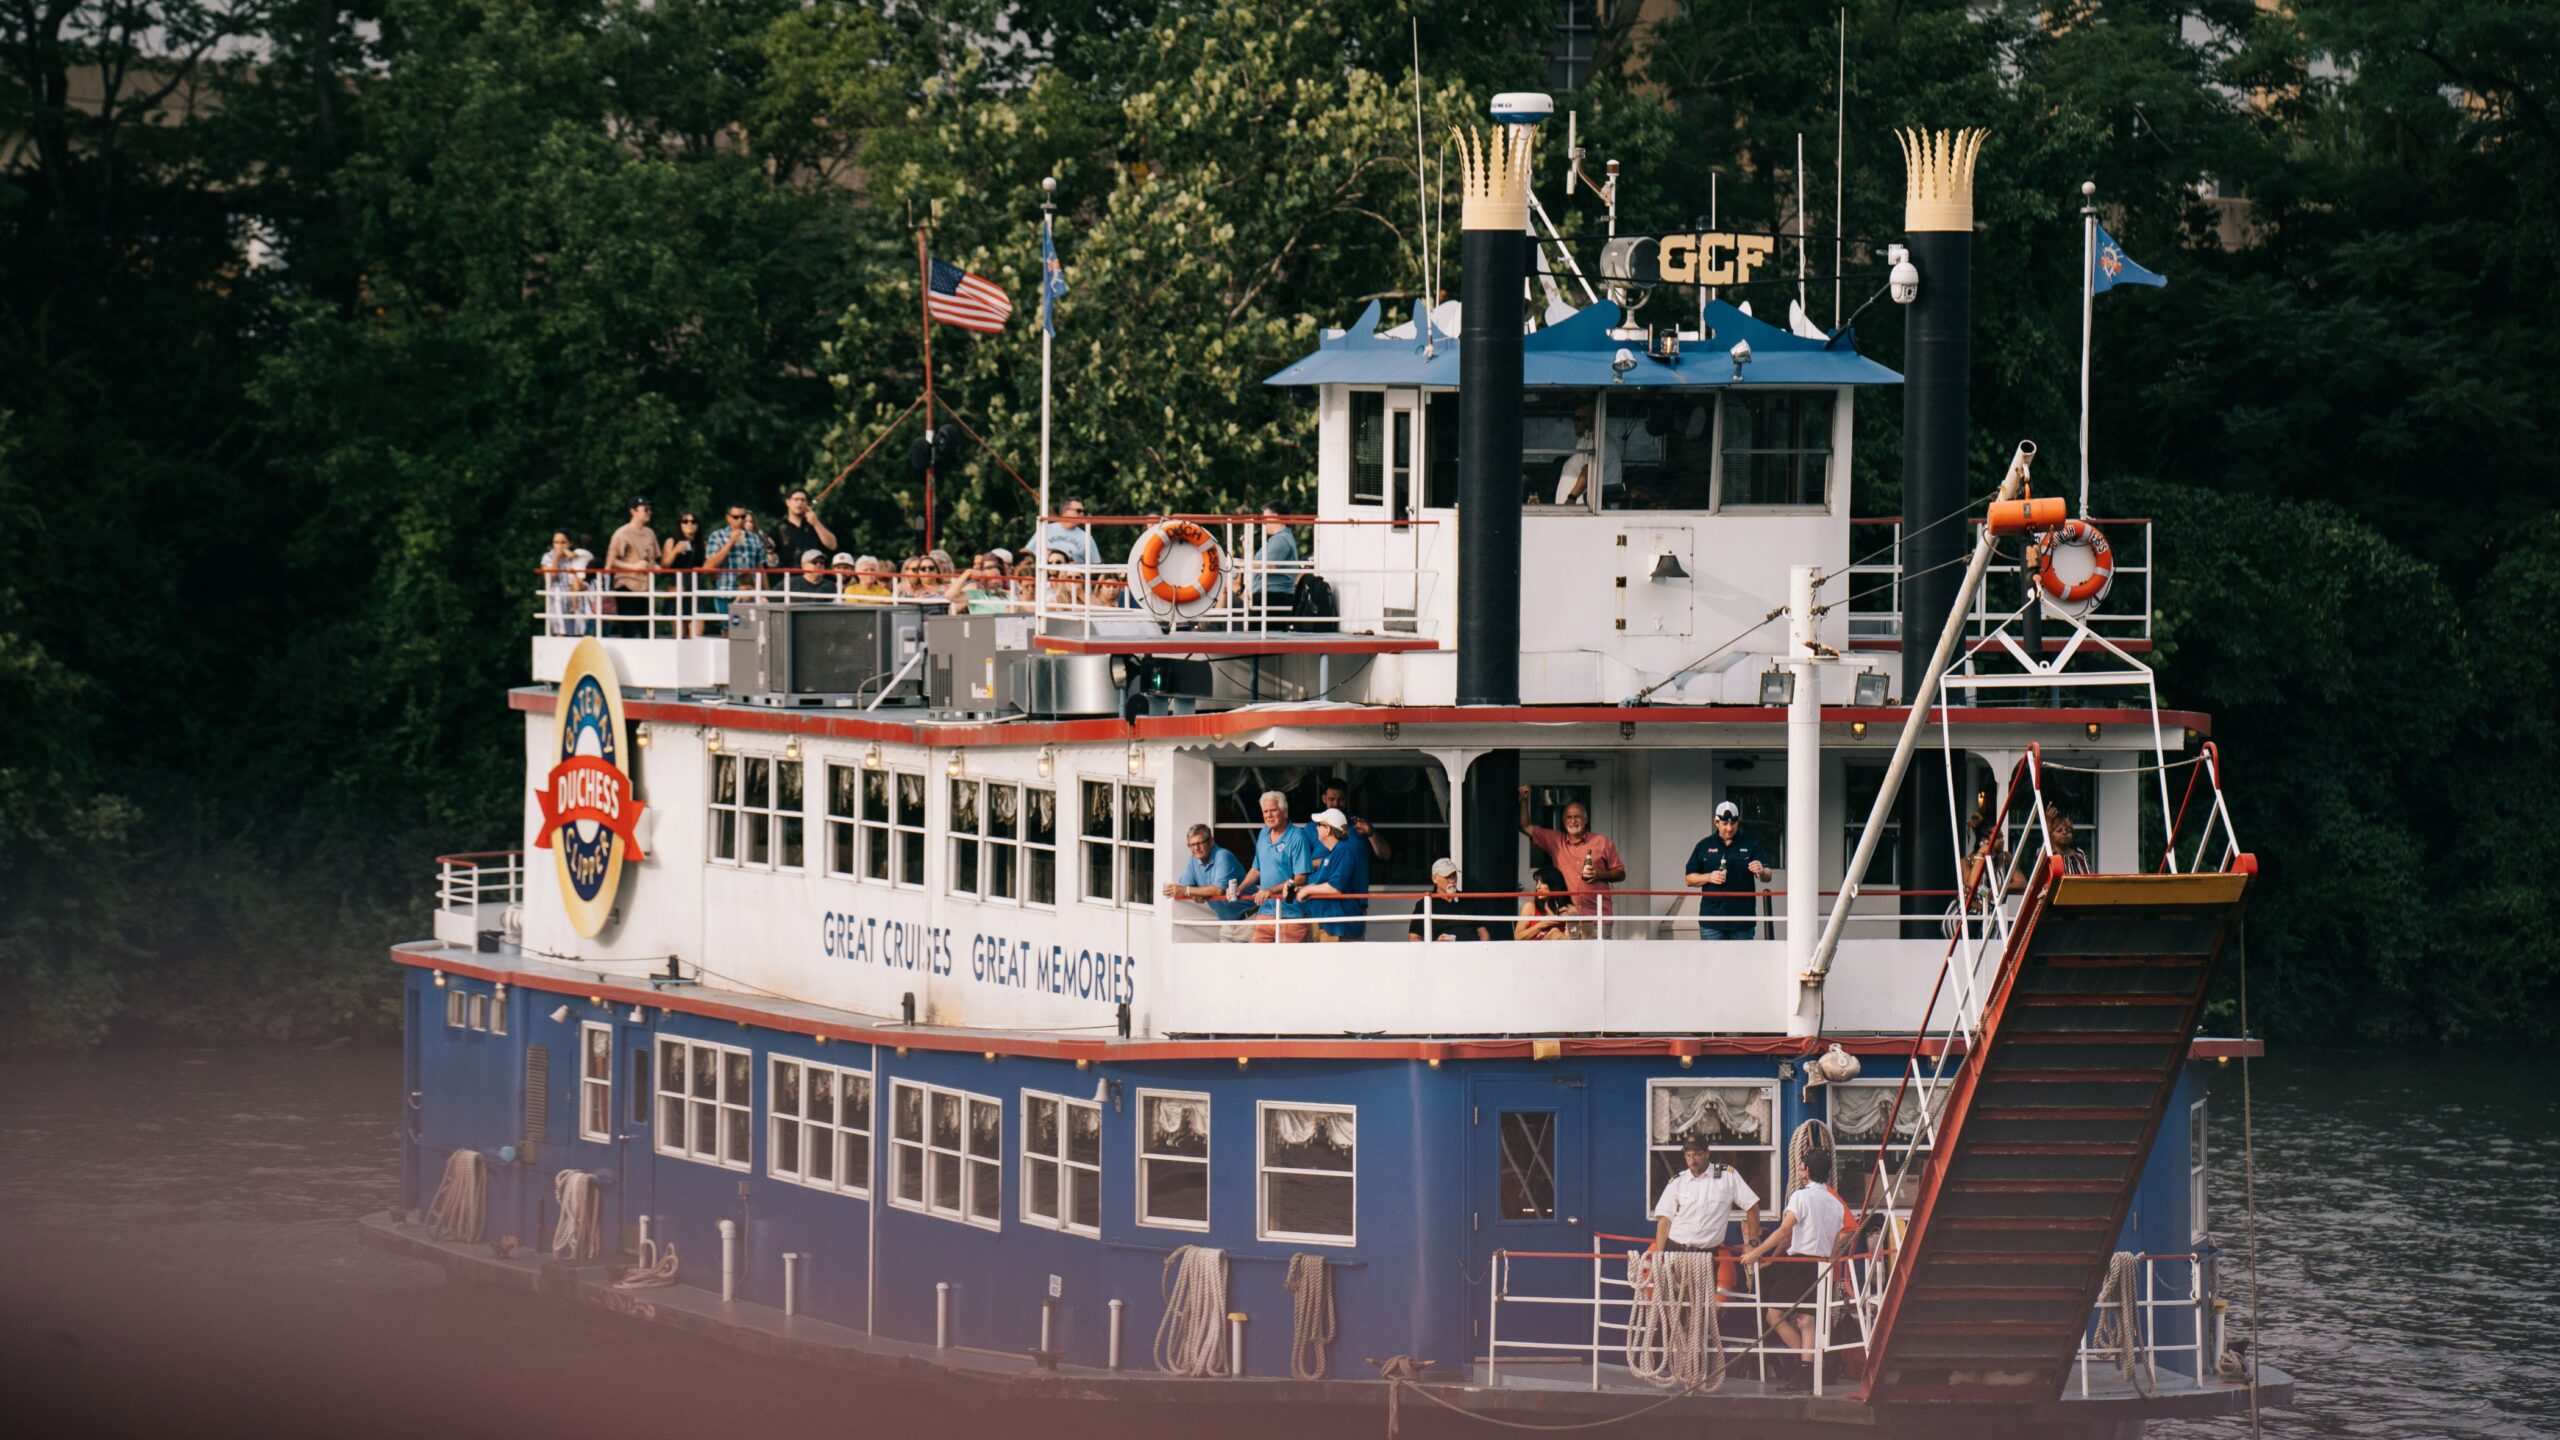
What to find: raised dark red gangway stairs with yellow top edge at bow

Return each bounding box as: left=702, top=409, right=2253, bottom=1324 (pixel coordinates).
left=1866, top=856, right=2255, bottom=1402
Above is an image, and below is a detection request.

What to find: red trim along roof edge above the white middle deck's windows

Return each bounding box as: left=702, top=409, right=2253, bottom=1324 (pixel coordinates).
left=507, top=687, right=2212, bottom=753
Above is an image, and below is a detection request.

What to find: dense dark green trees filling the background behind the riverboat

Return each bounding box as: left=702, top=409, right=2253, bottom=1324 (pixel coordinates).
left=0, top=0, right=2560, bottom=1043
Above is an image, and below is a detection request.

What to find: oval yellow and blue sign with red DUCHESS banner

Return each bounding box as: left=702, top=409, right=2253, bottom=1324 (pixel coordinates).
left=532, top=638, right=648, bottom=940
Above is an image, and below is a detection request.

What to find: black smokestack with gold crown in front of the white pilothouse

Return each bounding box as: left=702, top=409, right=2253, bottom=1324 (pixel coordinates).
left=1457, top=92, right=1556, bottom=889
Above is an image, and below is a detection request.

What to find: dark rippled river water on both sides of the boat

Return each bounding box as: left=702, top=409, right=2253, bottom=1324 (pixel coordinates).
left=0, top=1048, right=2560, bottom=1440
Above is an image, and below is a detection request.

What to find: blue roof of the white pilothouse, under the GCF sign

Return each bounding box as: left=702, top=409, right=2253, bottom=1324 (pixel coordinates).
left=1262, top=300, right=1902, bottom=389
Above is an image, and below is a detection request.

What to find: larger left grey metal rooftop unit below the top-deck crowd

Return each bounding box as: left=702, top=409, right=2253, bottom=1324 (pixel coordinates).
left=730, top=600, right=924, bottom=707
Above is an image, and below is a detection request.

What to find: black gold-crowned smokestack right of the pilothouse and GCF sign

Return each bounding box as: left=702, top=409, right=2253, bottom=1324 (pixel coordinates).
left=1892, top=128, right=1989, bottom=930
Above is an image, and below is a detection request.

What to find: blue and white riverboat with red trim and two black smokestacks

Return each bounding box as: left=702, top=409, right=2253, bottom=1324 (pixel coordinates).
left=364, top=97, right=2291, bottom=1437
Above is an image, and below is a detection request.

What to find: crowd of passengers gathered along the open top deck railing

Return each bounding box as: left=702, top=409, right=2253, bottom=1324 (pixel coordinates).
left=535, top=489, right=1298, bottom=638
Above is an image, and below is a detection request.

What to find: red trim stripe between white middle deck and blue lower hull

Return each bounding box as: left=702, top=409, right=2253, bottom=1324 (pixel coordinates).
left=392, top=945, right=2266, bottom=1061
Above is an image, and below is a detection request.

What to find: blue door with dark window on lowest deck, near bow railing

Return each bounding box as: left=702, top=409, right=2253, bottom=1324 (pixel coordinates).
left=1467, top=1074, right=1592, bottom=1371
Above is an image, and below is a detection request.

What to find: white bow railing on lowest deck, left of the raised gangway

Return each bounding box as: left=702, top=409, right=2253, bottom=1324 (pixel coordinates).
left=1485, top=1232, right=1887, bottom=1394
